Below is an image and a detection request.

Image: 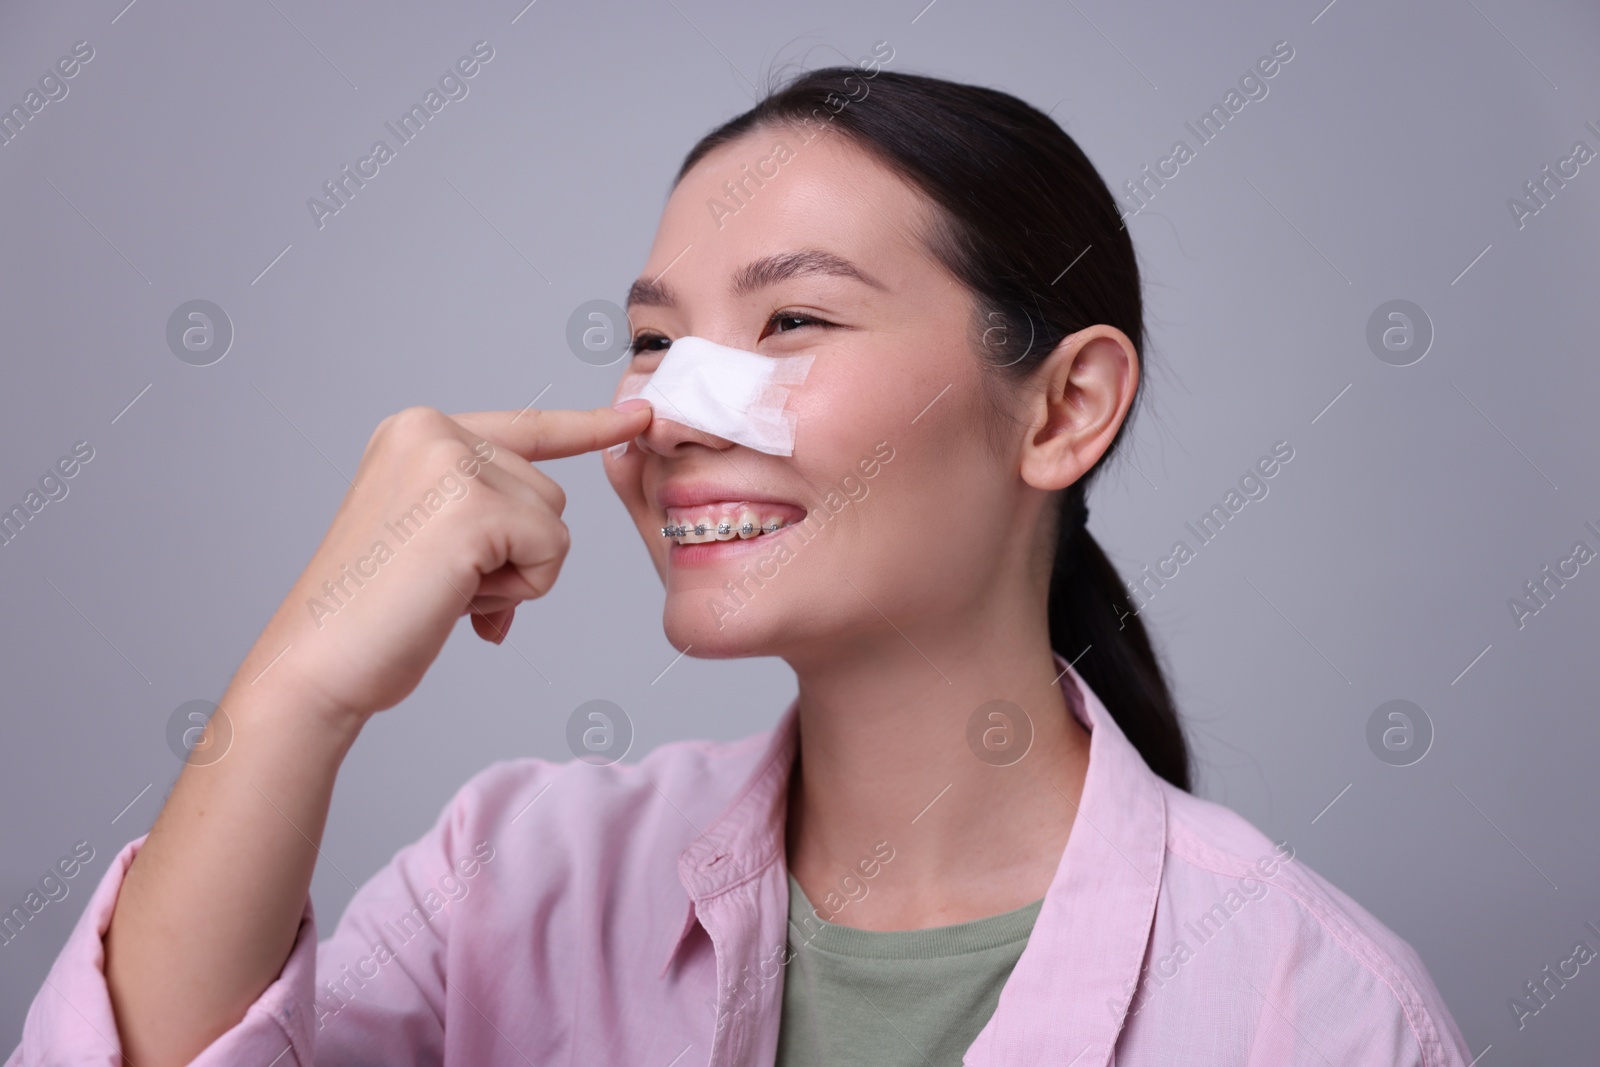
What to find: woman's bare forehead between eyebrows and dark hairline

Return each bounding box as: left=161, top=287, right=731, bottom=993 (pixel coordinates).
left=634, top=126, right=941, bottom=301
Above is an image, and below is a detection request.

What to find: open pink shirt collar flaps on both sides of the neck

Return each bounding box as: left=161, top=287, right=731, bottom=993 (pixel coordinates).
left=662, top=654, right=1166, bottom=1067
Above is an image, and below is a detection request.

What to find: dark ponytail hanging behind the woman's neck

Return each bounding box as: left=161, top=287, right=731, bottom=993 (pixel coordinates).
left=1050, top=480, right=1189, bottom=790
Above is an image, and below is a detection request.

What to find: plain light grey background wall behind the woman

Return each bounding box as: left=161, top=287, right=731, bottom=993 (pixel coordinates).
left=0, top=0, right=1600, bottom=1067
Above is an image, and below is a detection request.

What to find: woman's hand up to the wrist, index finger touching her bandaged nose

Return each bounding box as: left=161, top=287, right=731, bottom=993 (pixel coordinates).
left=240, top=402, right=650, bottom=735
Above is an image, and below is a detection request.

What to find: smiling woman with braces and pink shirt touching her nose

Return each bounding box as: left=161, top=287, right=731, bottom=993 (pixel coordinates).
left=13, top=64, right=1467, bottom=1067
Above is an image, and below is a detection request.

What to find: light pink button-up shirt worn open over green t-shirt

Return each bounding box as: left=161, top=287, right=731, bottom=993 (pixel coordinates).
left=6, top=657, right=1469, bottom=1067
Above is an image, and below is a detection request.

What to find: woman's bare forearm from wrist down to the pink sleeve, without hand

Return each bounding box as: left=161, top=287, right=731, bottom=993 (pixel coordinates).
left=106, top=680, right=358, bottom=1067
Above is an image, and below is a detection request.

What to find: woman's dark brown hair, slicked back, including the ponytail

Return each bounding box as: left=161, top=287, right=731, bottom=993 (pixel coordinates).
left=675, top=67, right=1189, bottom=789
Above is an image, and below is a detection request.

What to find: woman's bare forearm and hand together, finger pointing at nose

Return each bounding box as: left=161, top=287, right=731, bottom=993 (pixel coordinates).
left=104, top=402, right=650, bottom=1067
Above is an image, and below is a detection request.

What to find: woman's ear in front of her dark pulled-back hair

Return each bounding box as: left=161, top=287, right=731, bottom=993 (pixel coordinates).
left=1021, top=323, right=1139, bottom=490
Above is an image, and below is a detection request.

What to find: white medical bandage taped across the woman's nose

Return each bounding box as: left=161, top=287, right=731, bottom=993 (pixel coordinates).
left=616, top=338, right=816, bottom=456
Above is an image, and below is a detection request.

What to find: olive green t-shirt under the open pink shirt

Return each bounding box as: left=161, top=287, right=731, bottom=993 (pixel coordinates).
left=778, top=875, right=1043, bottom=1067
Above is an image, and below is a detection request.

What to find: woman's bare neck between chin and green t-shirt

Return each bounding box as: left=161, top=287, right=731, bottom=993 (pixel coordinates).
left=787, top=611, right=1088, bottom=929
